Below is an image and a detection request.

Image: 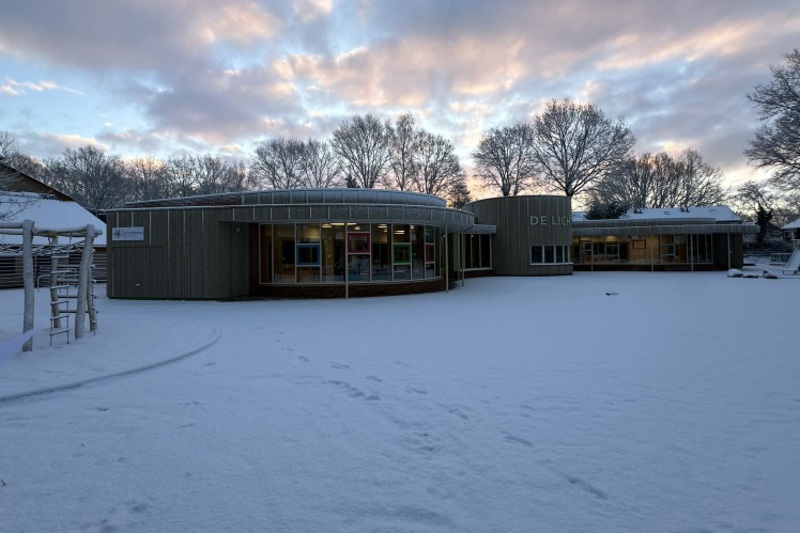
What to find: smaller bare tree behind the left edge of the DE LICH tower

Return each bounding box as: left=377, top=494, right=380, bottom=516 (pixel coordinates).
left=472, top=123, right=538, bottom=196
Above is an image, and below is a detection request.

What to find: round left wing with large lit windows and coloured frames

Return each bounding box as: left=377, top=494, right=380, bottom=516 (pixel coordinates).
left=106, top=188, right=475, bottom=299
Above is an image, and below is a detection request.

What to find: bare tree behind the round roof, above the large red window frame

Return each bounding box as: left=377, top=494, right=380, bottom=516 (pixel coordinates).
left=331, top=114, right=391, bottom=189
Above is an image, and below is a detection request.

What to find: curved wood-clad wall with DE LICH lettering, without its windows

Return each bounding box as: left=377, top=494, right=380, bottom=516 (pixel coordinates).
left=467, top=196, right=572, bottom=276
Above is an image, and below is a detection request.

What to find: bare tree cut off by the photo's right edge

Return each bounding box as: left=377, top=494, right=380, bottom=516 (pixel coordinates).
left=744, top=48, right=800, bottom=192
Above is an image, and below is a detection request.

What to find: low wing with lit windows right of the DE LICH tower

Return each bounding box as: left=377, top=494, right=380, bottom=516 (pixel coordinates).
left=572, top=205, right=758, bottom=270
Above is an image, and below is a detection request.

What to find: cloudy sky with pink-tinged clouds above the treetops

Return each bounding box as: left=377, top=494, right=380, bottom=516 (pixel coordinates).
left=0, top=0, right=800, bottom=193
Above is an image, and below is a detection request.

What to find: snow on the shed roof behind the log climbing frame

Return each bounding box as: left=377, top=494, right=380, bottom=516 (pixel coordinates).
left=0, top=191, right=106, bottom=246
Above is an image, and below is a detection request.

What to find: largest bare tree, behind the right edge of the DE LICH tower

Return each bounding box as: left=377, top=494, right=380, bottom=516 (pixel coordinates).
left=533, top=99, right=636, bottom=198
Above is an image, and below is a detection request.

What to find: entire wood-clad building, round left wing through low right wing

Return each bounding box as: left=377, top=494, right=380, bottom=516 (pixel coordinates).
left=106, top=189, right=757, bottom=299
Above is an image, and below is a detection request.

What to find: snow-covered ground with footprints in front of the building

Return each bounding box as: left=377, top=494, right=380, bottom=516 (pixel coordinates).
left=0, top=272, right=800, bottom=533
